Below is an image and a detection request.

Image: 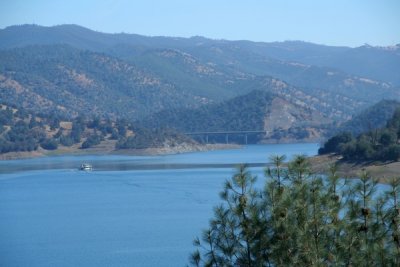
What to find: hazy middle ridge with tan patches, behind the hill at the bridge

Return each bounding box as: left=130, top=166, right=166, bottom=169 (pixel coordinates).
left=112, top=44, right=400, bottom=120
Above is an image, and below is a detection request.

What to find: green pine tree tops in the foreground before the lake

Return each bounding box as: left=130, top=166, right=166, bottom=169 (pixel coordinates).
left=190, top=156, right=400, bottom=266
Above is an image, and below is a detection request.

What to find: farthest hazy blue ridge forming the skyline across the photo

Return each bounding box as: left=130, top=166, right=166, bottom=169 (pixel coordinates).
left=0, top=25, right=400, bottom=86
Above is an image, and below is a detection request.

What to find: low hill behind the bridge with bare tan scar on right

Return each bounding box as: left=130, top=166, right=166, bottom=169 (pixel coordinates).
left=138, top=90, right=329, bottom=142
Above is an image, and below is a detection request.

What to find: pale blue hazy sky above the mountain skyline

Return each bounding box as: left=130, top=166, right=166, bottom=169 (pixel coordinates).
left=0, top=0, right=400, bottom=46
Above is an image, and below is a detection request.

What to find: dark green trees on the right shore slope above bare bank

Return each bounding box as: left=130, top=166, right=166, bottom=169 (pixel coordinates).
left=318, top=109, right=400, bottom=161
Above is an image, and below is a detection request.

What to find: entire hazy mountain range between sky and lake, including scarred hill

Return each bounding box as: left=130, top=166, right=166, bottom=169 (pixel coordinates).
left=0, top=25, right=400, bottom=143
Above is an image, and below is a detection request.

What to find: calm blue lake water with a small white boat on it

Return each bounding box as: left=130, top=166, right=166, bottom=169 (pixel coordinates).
left=0, top=144, right=318, bottom=267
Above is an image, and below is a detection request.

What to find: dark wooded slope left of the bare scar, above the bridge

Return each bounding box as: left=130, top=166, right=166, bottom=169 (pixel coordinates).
left=139, top=90, right=273, bottom=142
